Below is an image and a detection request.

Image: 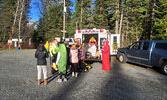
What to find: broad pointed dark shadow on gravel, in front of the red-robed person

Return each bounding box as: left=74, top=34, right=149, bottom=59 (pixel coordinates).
left=101, top=59, right=137, bottom=100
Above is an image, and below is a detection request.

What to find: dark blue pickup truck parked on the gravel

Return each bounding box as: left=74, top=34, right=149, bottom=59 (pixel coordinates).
left=117, top=40, right=167, bottom=75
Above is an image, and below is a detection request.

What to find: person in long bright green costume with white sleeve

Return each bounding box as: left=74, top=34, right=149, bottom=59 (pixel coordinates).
left=56, top=43, right=67, bottom=82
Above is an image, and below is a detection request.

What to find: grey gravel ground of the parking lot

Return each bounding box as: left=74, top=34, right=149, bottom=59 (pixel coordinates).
left=0, top=50, right=167, bottom=100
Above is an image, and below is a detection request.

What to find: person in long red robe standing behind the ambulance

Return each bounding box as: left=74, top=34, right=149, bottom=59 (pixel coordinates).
left=102, top=41, right=111, bottom=70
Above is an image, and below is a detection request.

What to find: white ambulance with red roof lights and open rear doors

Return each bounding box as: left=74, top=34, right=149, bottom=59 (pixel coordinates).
left=74, top=28, right=120, bottom=55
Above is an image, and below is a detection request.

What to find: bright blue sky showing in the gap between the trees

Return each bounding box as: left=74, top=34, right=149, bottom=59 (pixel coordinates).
left=30, top=0, right=75, bottom=21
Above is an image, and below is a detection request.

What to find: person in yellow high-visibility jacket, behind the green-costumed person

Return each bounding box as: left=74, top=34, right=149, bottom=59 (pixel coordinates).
left=49, top=39, right=59, bottom=74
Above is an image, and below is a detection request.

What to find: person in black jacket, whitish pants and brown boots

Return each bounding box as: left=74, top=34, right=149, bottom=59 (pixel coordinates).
left=35, top=44, right=49, bottom=85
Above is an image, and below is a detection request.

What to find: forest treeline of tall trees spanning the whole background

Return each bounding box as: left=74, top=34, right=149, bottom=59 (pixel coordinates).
left=0, top=0, right=167, bottom=45
